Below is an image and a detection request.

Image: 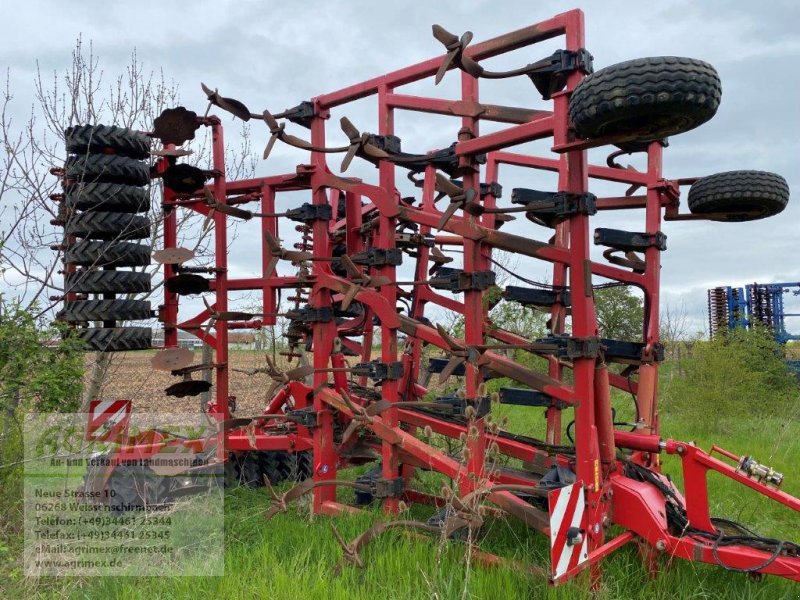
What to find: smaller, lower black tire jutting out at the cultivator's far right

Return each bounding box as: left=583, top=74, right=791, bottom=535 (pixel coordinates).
left=688, top=171, right=789, bottom=221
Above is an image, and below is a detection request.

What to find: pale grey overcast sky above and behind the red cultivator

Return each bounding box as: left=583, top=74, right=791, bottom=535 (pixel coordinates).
left=0, top=0, right=800, bottom=336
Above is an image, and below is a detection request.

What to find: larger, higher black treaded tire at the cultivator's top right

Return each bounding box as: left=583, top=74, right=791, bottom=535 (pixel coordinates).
left=569, top=56, right=722, bottom=143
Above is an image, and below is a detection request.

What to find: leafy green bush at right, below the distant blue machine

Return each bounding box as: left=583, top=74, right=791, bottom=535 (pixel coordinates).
left=663, top=327, right=800, bottom=432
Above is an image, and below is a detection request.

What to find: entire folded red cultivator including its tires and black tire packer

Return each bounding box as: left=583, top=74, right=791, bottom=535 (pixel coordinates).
left=53, top=10, right=800, bottom=584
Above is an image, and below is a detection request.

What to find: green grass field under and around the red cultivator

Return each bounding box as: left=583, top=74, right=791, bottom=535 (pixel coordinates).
left=0, top=350, right=800, bottom=600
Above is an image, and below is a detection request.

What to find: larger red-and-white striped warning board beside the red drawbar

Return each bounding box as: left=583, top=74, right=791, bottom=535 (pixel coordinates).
left=548, top=483, right=589, bottom=581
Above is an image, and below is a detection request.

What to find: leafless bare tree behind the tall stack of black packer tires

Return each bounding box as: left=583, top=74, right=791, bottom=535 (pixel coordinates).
left=0, top=37, right=257, bottom=408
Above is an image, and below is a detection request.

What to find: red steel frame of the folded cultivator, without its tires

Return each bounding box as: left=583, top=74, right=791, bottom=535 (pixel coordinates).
left=61, top=10, right=800, bottom=583
